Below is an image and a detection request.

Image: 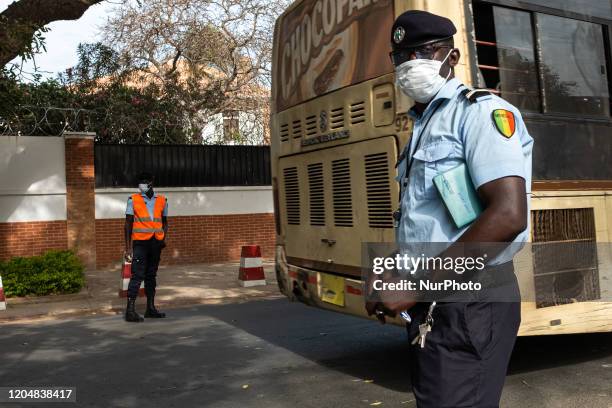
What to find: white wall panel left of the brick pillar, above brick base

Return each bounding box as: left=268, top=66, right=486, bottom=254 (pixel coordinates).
left=0, top=136, right=66, bottom=222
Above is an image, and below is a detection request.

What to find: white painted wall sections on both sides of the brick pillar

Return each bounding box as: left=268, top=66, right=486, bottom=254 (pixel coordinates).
left=0, top=136, right=274, bottom=222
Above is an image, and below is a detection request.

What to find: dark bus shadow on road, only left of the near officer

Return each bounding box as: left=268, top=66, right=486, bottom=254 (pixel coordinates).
left=209, top=299, right=411, bottom=392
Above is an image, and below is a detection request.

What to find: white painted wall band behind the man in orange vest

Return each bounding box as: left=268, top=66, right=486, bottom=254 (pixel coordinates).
left=96, top=186, right=274, bottom=219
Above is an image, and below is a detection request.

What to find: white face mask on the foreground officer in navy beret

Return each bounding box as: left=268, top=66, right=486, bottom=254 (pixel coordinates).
left=395, top=50, right=453, bottom=103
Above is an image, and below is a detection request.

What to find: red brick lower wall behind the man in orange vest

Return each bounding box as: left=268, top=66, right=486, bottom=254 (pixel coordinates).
left=96, top=213, right=276, bottom=268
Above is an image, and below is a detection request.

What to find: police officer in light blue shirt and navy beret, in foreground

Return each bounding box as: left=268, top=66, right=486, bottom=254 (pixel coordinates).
left=366, top=11, right=533, bottom=408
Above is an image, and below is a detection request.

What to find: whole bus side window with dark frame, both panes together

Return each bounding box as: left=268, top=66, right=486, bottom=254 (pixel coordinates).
left=474, top=3, right=610, bottom=117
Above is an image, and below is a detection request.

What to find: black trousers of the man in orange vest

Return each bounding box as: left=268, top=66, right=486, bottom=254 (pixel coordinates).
left=128, top=237, right=162, bottom=298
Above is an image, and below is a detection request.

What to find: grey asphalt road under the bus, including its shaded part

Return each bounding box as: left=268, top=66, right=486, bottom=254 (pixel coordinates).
left=0, top=299, right=612, bottom=408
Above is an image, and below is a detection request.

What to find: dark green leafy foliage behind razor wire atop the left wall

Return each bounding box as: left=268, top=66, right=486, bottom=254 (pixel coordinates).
left=0, top=43, right=206, bottom=144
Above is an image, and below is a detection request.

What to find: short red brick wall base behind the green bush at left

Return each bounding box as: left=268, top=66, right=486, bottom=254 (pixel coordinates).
left=0, top=221, right=67, bottom=260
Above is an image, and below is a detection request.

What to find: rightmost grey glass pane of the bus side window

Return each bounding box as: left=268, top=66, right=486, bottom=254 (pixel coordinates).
left=537, top=13, right=610, bottom=116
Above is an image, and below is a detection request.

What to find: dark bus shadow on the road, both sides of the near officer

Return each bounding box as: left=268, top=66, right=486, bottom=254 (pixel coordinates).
left=204, top=299, right=612, bottom=392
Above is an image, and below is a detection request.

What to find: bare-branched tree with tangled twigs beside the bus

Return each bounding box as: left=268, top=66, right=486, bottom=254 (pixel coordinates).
left=104, top=0, right=289, bottom=145
